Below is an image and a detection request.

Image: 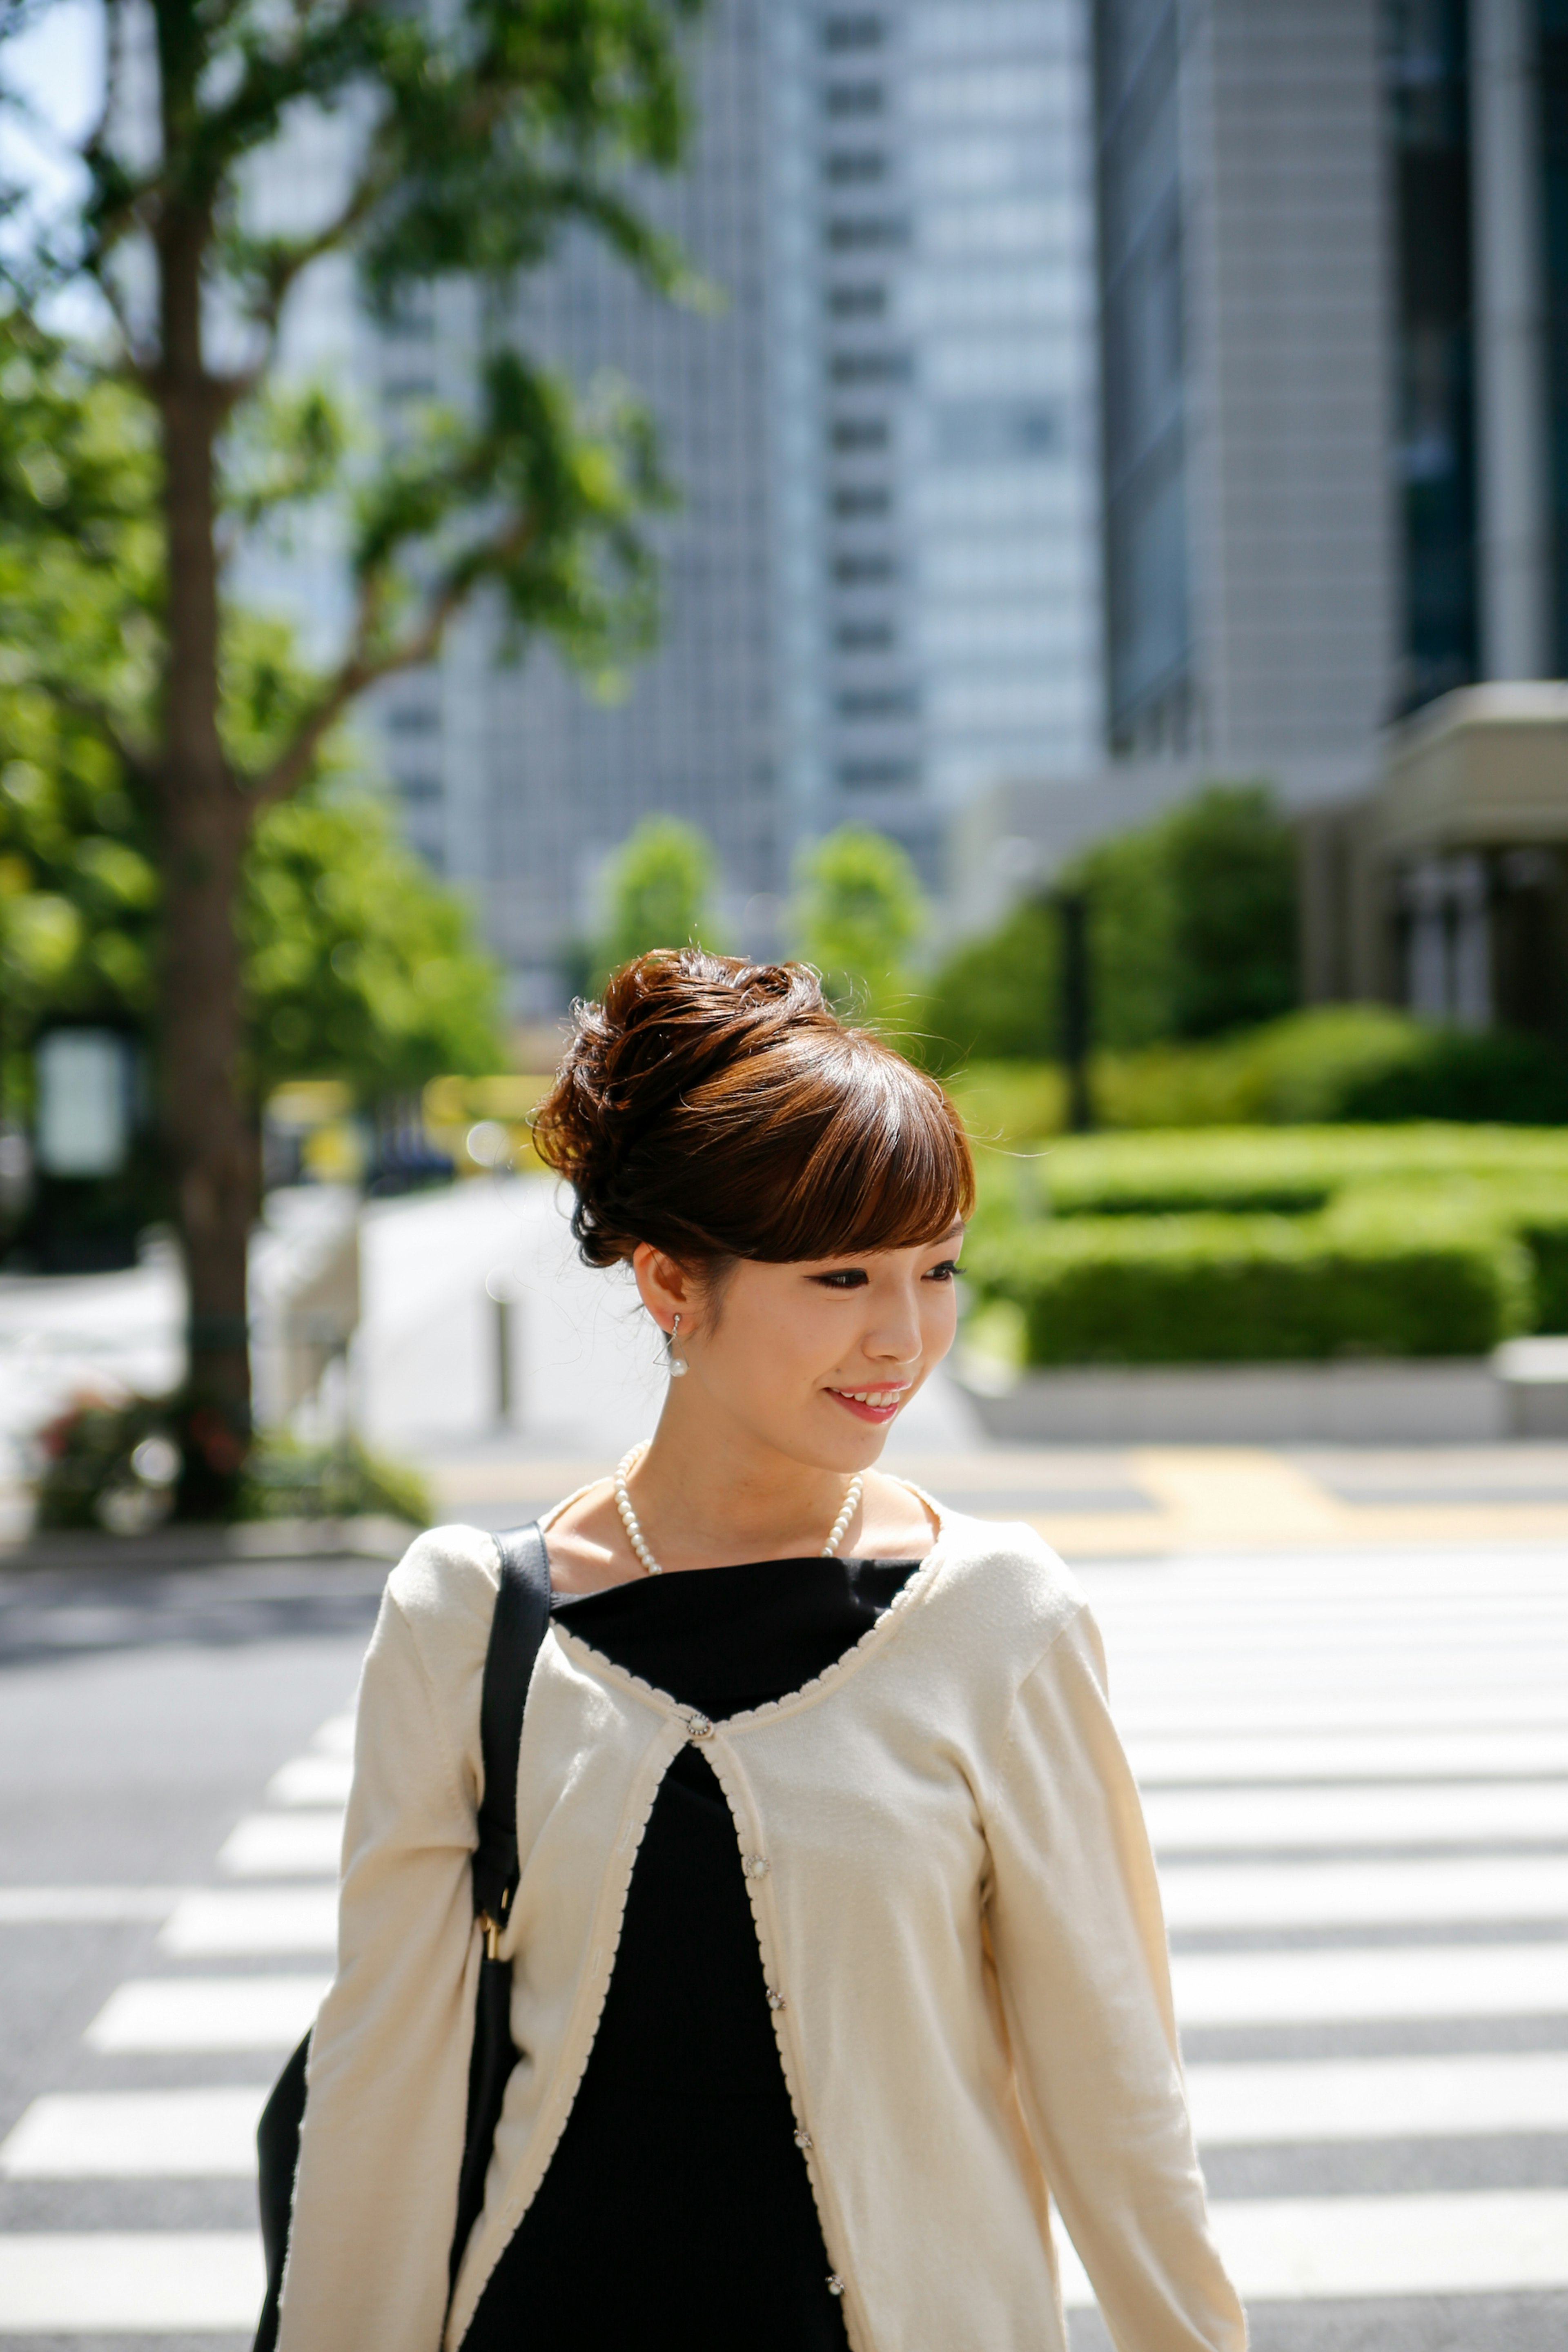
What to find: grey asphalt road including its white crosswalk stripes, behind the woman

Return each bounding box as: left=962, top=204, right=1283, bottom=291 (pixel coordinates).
left=0, top=1548, right=1568, bottom=2352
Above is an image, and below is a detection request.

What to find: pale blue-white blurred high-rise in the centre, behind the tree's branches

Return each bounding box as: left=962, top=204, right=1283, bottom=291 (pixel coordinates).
left=255, top=0, right=1102, bottom=1014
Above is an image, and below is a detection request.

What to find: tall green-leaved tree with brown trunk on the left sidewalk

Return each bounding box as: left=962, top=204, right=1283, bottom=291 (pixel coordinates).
left=0, top=0, right=696, bottom=1451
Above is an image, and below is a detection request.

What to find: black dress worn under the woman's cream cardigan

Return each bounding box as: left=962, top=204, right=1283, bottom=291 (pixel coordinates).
left=463, top=1559, right=917, bottom=2352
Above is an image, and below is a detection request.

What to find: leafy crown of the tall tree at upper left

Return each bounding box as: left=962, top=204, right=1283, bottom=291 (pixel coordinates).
left=0, top=0, right=698, bottom=793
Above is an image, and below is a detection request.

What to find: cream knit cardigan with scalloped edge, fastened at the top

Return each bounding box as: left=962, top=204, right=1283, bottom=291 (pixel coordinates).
left=280, top=1512, right=1246, bottom=2352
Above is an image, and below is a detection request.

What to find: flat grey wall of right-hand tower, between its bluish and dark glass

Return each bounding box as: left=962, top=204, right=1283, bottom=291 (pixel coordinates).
left=1183, top=0, right=1396, bottom=771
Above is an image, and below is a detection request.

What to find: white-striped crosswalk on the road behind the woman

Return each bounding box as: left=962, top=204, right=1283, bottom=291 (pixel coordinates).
left=0, top=1550, right=1568, bottom=2352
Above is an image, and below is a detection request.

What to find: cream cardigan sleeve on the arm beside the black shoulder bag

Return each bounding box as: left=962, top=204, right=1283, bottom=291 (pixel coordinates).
left=277, top=1538, right=494, bottom=2352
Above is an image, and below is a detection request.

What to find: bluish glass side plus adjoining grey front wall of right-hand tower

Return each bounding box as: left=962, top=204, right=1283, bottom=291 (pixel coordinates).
left=1093, top=0, right=1394, bottom=771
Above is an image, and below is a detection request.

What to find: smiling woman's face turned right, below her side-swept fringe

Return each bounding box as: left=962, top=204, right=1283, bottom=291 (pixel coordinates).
left=635, top=1225, right=964, bottom=1472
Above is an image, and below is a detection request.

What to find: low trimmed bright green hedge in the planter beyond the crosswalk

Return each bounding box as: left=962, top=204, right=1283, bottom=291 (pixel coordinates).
left=964, top=1124, right=1568, bottom=1364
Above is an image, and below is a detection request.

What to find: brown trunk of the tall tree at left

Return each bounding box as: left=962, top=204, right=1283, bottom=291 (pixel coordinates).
left=153, top=212, right=258, bottom=1512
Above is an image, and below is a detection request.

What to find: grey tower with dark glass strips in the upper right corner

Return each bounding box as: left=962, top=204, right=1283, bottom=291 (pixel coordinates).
left=1096, top=0, right=1568, bottom=769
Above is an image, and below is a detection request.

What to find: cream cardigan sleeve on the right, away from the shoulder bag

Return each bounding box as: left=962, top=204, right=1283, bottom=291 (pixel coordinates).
left=985, top=1609, right=1246, bottom=2352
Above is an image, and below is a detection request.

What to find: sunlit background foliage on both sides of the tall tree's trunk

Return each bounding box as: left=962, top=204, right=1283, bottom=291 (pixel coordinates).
left=0, top=318, right=501, bottom=1101
